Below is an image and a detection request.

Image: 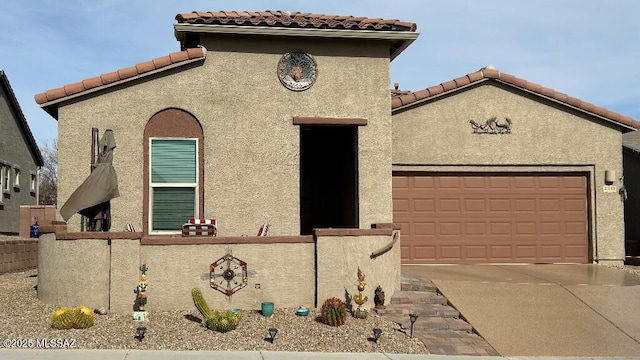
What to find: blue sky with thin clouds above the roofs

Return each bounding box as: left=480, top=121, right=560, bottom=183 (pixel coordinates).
left=0, top=0, right=640, bottom=145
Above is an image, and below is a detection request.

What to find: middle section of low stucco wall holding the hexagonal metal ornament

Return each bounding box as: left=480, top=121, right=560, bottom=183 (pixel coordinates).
left=136, top=243, right=315, bottom=310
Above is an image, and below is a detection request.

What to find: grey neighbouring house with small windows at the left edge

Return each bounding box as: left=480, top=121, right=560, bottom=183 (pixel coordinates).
left=0, top=70, right=43, bottom=234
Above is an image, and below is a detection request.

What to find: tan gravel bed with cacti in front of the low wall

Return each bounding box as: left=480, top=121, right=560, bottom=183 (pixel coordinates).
left=0, top=270, right=428, bottom=354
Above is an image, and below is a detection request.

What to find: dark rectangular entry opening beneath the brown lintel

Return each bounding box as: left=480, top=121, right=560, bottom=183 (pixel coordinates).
left=300, top=126, right=359, bottom=235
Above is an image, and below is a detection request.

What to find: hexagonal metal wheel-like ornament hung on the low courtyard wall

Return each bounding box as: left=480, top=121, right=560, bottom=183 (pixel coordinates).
left=209, top=249, right=247, bottom=297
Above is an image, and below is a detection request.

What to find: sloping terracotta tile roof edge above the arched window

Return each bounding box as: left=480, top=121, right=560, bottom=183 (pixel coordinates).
left=35, top=47, right=207, bottom=105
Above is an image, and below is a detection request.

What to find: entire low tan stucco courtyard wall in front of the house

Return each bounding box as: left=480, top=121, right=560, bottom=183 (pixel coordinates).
left=38, top=233, right=400, bottom=314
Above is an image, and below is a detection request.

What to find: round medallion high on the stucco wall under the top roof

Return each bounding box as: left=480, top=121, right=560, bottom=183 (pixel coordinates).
left=278, top=51, right=318, bottom=91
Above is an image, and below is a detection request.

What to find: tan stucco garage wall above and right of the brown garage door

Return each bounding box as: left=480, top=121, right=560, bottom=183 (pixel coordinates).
left=393, top=83, right=624, bottom=261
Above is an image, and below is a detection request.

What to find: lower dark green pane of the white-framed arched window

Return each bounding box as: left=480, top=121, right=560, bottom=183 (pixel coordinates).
left=153, top=187, right=196, bottom=230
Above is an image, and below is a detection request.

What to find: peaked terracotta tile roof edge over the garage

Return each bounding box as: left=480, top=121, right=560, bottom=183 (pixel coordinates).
left=391, top=67, right=640, bottom=129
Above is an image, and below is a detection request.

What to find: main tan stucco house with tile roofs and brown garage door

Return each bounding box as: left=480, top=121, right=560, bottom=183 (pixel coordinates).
left=36, top=12, right=640, bottom=263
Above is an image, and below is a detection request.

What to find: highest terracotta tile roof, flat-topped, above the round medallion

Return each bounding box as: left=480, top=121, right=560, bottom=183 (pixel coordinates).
left=176, top=10, right=417, bottom=31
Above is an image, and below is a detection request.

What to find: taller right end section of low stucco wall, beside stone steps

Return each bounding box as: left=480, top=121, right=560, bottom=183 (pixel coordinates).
left=317, top=235, right=400, bottom=308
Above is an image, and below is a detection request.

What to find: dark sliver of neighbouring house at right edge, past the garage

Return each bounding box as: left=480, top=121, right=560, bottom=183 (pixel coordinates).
left=622, top=131, right=640, bottom=256
